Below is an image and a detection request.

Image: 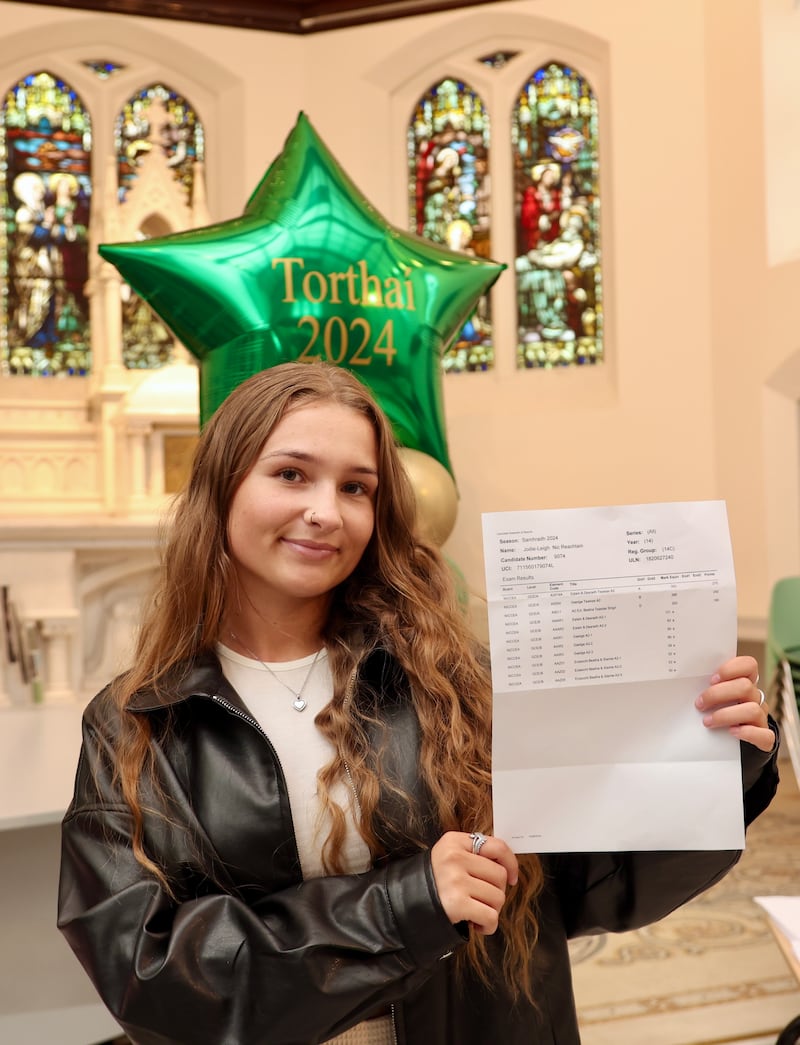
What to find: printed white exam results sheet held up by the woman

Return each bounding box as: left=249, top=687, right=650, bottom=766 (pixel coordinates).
left=483, top=501, right=745, bottom=853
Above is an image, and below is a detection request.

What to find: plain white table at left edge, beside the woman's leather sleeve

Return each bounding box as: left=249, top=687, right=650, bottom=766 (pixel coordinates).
left=0, top=704, right=120, bottom=1045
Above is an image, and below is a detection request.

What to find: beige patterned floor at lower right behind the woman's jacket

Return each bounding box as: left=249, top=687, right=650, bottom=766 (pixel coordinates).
left=572, top=761, right=800, bottom=1045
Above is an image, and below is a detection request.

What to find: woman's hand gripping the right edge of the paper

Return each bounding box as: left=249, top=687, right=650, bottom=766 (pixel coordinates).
left=695, top=656, right=775, bottom=751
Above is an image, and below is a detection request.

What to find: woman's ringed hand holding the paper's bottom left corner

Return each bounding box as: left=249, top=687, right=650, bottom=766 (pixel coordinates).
left=430, top=831, right=518, bottom=935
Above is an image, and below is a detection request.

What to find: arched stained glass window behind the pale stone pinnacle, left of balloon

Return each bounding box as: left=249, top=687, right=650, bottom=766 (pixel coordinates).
left=114, top=84, right=205, bottom=370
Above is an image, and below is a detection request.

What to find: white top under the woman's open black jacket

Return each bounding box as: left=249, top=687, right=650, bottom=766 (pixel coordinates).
left=216, top=643, right=370, bottom=878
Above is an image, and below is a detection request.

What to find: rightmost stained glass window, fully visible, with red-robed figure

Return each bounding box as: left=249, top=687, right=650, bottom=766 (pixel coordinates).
left=512, top=62, right=603, bottom=367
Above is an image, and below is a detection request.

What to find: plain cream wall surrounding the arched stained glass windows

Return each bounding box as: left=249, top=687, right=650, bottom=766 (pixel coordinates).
left=0, top=0, right=800, bottom=634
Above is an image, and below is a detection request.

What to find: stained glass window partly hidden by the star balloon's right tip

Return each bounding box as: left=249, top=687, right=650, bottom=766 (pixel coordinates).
left=408, top=79, right=494, bottom=372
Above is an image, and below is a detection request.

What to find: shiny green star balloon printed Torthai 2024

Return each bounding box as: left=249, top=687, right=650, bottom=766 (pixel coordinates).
left=99, top=113, right=505, bottom=472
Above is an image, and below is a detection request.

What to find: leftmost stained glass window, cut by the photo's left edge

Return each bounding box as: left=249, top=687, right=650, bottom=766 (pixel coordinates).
left=0, top=72, right=92, bottom=375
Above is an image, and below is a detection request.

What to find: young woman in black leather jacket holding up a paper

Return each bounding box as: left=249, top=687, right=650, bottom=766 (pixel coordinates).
left=58, top=364, right=777, bottom=1045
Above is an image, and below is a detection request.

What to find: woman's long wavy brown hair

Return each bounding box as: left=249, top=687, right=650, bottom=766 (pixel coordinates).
left=109, top=363, right=542, bottom=997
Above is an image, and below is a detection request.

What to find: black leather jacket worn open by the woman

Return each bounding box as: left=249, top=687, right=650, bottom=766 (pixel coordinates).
left=58, top=653, right=777, bottom=1045
